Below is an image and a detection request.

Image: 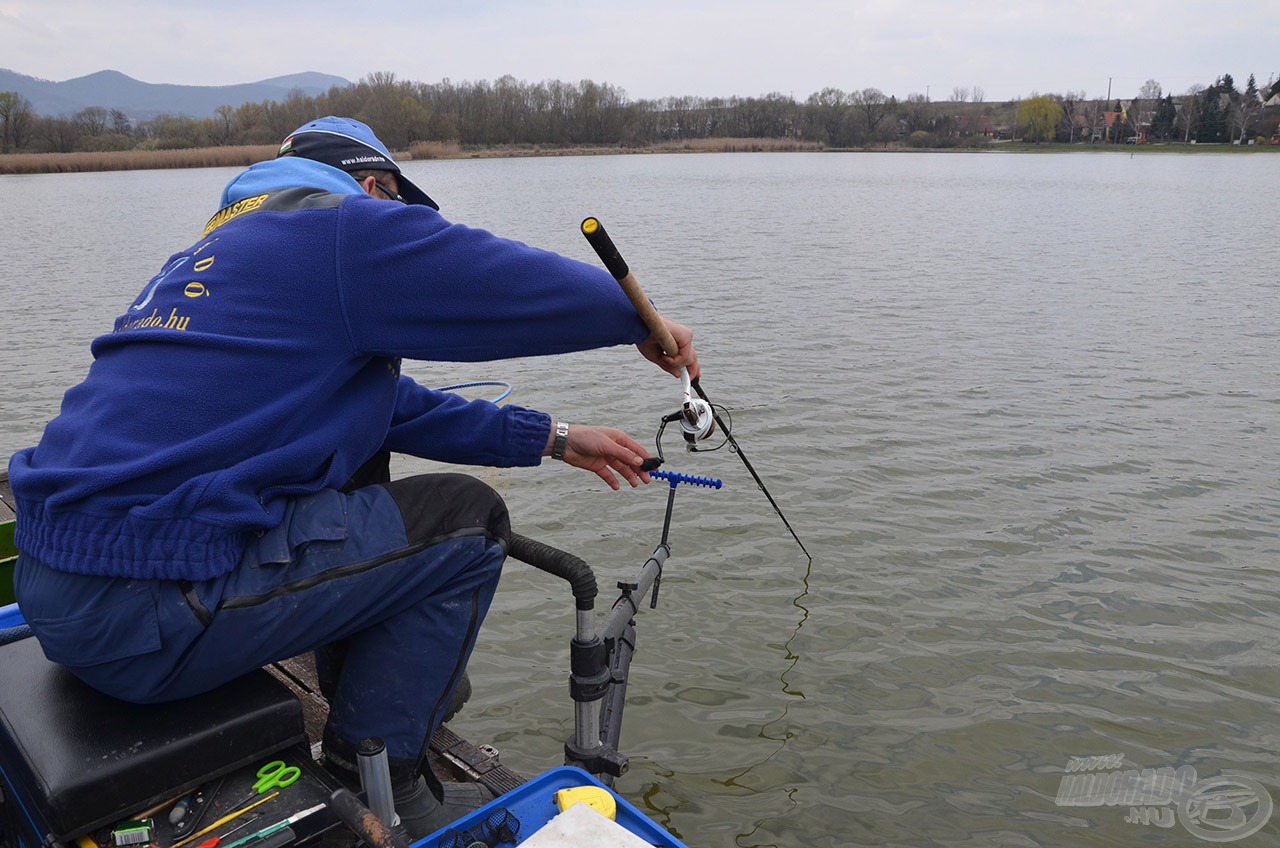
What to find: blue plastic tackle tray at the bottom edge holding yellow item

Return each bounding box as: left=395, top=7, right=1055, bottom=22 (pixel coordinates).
left=412, top=766, right=689, bottom=848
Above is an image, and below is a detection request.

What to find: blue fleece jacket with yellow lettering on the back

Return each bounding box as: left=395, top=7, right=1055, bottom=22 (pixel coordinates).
left=9, top=158, right=648, bottom=580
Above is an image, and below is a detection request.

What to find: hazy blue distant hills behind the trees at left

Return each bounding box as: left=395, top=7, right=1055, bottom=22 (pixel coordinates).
left=0, top=69, right=351, bottom=120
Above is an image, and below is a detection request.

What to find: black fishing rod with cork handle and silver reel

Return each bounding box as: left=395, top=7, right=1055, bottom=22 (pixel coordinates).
left=582, top=218, right=813, bottom=564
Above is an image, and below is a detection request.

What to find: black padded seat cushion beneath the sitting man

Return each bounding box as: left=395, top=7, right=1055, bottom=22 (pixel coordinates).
left=0, top=639, right=306, bottom=842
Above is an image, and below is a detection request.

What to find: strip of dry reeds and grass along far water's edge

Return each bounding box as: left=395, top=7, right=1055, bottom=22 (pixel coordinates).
left=0, top=138, right=1280, bottom=175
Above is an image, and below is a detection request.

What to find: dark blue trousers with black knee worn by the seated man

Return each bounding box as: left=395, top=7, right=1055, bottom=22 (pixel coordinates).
left=14, top=474, right=511, bottom=767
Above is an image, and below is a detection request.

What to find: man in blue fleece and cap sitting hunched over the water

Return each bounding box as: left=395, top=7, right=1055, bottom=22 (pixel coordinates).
left=9, top=118, right=698, bottom=836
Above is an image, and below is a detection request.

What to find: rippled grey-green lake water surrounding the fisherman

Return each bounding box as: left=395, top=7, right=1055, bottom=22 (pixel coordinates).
left=0, top=152, right=1280, bottom=848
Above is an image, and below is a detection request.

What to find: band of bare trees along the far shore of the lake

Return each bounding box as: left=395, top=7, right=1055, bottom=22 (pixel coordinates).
left=0, top=72, right=1280, bottom=152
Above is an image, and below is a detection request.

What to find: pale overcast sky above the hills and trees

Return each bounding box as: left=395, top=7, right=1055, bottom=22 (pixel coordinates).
left=0, top=0, right=1280, bottom=100
